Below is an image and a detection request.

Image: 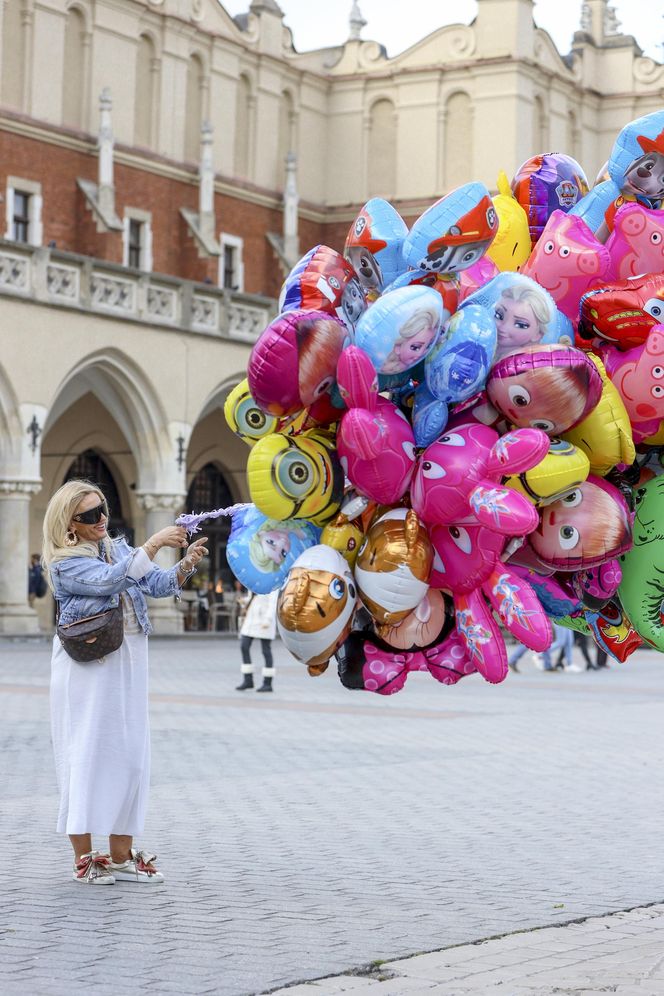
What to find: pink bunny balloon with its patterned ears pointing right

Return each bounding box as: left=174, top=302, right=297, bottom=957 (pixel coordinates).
left=410, top=423, right=549, bottom=536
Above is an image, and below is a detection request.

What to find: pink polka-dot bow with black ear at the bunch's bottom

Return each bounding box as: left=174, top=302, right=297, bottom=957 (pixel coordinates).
left=336, top=630, right=476, bottom=695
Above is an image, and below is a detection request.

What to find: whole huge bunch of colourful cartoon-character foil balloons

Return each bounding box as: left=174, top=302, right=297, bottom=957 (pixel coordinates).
left=197, top=105, right=664, bottom=694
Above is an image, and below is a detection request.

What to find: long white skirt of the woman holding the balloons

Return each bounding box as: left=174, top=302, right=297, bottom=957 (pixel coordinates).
left=51, top=633, right=150, bottom=837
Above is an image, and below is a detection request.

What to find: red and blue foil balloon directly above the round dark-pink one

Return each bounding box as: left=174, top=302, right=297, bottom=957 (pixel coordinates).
left=279, top=245, right=367, bottom=328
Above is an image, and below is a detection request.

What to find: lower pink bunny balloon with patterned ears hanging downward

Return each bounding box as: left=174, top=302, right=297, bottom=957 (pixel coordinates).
left=430, top=505, right=551, bottom=682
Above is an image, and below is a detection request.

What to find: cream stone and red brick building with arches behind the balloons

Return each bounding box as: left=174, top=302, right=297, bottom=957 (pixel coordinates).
left=0, top=0, right=664, bottom=632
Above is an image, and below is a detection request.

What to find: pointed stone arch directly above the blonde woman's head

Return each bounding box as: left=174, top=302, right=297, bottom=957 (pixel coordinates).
left=44, top=349, right=173, bottom=491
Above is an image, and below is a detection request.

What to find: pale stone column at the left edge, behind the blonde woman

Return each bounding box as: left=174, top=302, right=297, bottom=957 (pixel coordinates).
left=0, top=480, right=41, bottom=634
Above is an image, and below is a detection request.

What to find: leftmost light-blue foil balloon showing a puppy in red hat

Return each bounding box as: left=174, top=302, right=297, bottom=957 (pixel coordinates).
left=344, top=197, right=408, bottom=302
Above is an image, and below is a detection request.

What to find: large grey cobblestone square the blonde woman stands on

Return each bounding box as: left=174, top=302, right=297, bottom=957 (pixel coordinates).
left=0, top=638, right=664, bottom=996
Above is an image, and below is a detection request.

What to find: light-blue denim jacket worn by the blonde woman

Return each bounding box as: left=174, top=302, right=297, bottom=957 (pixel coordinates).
left=50, top=537, right=181, bottom=635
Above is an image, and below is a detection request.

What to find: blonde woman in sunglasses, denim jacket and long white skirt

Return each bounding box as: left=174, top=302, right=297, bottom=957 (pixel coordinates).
left=42, top=481, right=207, bottom=885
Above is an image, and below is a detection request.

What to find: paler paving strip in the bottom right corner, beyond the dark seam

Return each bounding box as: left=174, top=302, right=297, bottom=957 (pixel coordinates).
left=274, top=905, right=664, bottom=996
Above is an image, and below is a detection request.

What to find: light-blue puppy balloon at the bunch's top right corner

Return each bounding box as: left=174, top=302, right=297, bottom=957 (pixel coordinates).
left=571, top=111, right=664, bottom=241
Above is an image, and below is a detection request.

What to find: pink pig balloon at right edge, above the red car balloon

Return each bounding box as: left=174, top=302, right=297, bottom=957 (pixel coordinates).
left=606, top=203, right=664, bottom=280
